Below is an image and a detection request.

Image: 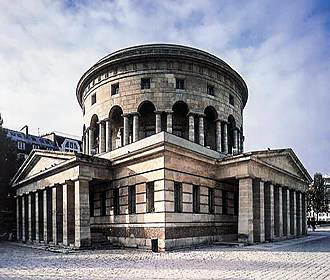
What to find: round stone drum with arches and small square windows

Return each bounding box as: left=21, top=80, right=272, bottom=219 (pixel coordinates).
left=77, top=44, right=248, bottom=154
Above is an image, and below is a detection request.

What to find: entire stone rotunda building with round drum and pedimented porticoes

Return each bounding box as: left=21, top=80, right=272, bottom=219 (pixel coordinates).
left=13, top=45, right=311, bottom=250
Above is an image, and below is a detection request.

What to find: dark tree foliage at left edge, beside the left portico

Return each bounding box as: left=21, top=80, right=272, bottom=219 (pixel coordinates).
left=0, top=127, right=22, bottom=210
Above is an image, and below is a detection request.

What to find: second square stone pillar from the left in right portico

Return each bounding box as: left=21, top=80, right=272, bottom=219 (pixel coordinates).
left=253, top=180, right=265, bottom=242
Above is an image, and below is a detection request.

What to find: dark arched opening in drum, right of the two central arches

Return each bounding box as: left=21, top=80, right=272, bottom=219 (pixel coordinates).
left=172, top=101, right=189, bottom=139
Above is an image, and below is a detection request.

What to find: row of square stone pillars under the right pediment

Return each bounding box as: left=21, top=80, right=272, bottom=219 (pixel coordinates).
left=238, top=177, right=307, bottom=243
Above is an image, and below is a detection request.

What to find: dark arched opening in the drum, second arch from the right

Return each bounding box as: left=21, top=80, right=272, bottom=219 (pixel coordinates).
left=204, top=106, right=218, bottom=150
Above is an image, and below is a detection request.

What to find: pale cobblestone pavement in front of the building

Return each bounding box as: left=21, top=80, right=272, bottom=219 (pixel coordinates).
left=0, top=230, right=330, bottom=280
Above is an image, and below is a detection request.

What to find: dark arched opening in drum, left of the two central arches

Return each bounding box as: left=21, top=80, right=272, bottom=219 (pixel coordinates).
left=138, top=101, right=156, bottom=139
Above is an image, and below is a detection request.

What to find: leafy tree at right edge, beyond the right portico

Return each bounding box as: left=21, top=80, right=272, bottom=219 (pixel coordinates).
left=307, top=173, right=328, bottom=221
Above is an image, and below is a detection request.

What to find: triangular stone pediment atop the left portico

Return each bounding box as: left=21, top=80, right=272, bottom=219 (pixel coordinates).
left=12, top=150, right=75, bottom=184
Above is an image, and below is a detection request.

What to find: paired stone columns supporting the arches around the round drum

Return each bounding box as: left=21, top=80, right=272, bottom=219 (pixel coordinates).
left=83, top=110, right=243, bottom=155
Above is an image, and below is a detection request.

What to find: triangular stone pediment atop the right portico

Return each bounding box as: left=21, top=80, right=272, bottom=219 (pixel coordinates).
left=252, top=149, right=311, bottom=181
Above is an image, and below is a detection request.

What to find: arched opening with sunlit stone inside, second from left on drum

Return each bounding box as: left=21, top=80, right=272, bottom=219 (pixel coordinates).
left=109, top=106, right=124, bottom=150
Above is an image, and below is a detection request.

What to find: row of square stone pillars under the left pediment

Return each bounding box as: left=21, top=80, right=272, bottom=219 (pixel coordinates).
left=16, top=179, right=91, bottom=247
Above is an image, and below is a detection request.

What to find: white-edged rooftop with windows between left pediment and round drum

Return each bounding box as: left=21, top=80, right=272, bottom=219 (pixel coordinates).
left=42, top=132, right=82, bottom=153
